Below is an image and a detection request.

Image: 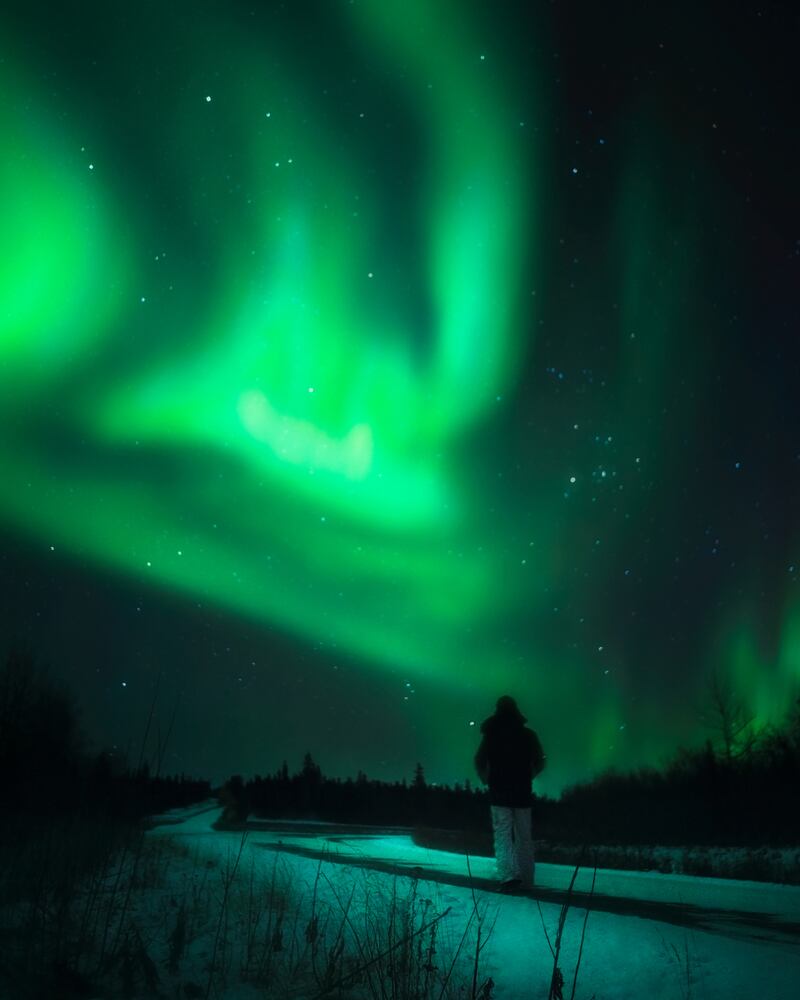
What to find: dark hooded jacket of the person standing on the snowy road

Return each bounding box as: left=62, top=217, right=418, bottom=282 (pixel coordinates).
left=475, top=696, right=545, bottom=809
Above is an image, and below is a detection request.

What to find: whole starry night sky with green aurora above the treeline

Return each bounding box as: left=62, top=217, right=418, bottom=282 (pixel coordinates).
left=0, top=0, right=800, bottom=794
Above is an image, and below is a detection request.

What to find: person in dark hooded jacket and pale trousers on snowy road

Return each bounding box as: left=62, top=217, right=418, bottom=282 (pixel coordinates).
left=475, top=695, right=545, bottom=889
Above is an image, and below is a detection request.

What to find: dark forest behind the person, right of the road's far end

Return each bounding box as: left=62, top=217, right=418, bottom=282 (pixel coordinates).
left=221, top=688, right=800, bottom=846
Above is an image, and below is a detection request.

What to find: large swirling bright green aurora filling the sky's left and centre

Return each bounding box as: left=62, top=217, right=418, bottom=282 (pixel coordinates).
left=0, top=3, right=531, bottom=687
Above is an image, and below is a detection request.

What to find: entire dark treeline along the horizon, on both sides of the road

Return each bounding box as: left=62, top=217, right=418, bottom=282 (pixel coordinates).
left=0, top=653, right=800, bottom=848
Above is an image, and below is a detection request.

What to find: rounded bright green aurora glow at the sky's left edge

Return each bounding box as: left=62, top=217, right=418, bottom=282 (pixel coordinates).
left=0, top=61, right=130, bottom=388
